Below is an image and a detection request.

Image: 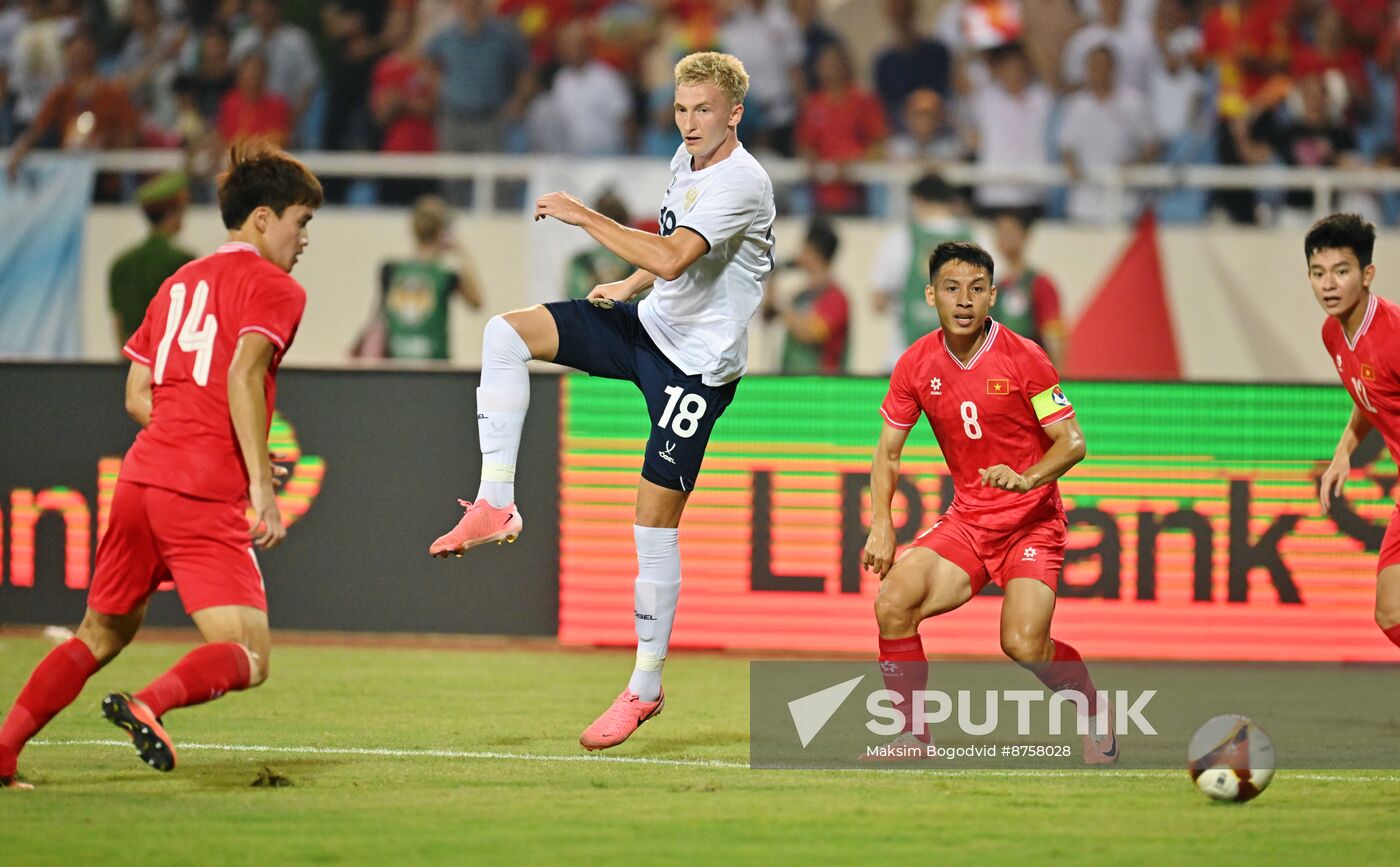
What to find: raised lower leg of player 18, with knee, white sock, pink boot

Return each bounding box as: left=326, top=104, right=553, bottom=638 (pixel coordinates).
left=428, top=305, right=559, bottom=557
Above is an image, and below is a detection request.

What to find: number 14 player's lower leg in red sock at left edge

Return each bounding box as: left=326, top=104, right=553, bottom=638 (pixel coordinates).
left=0, top=602, right=146, bottom=789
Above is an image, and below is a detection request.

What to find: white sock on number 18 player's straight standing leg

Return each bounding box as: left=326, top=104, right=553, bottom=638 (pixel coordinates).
left=627, top=524, right=680, bottom=702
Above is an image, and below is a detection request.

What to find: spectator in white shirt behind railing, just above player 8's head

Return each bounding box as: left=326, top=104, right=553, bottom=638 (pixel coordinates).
left=967, top=42, right=1054, bottom=213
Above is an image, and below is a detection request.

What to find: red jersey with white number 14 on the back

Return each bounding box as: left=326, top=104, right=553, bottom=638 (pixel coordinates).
left=120, top=244, right=307, bottom=500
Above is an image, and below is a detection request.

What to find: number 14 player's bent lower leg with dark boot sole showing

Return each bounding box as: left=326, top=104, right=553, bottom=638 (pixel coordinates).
left=102, top=605, right=272, bottom=770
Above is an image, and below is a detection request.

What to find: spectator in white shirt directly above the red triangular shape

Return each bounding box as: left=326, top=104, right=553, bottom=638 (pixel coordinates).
left=1060, top=45, right=1156, bottom=223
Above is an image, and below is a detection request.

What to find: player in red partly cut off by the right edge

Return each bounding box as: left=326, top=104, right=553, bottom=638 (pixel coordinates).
left=1303, top=214, right=1400, bottom=647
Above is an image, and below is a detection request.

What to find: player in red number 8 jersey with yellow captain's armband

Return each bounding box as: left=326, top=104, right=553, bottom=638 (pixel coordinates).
left=862, top=241, right=1119, bottom=763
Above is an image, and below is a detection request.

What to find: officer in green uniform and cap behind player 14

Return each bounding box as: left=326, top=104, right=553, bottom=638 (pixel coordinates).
left=106, top=171, right=195, bottom=347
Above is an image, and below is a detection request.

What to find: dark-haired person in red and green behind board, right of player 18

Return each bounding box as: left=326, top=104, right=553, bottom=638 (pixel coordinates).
left=774, top=217, right=851, bottom=374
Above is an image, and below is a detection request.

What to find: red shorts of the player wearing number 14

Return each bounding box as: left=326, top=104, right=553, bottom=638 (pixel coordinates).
left=88, top=480, right=267, bottom=615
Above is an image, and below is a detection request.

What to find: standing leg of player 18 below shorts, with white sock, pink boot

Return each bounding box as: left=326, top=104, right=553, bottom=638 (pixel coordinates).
left=578, top=479, right=690, bottom=749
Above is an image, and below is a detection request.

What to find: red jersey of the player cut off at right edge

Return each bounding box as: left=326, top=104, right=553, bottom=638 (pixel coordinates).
left=1322, top=296, right=1400, bottom=462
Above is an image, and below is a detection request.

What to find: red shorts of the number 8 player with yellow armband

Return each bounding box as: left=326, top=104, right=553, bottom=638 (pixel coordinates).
left=910, top=511, right=1068, bottom=595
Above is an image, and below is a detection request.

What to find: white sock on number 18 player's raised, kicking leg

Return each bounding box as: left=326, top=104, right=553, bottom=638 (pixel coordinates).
left=476, top=317, right=531, bottom=508
